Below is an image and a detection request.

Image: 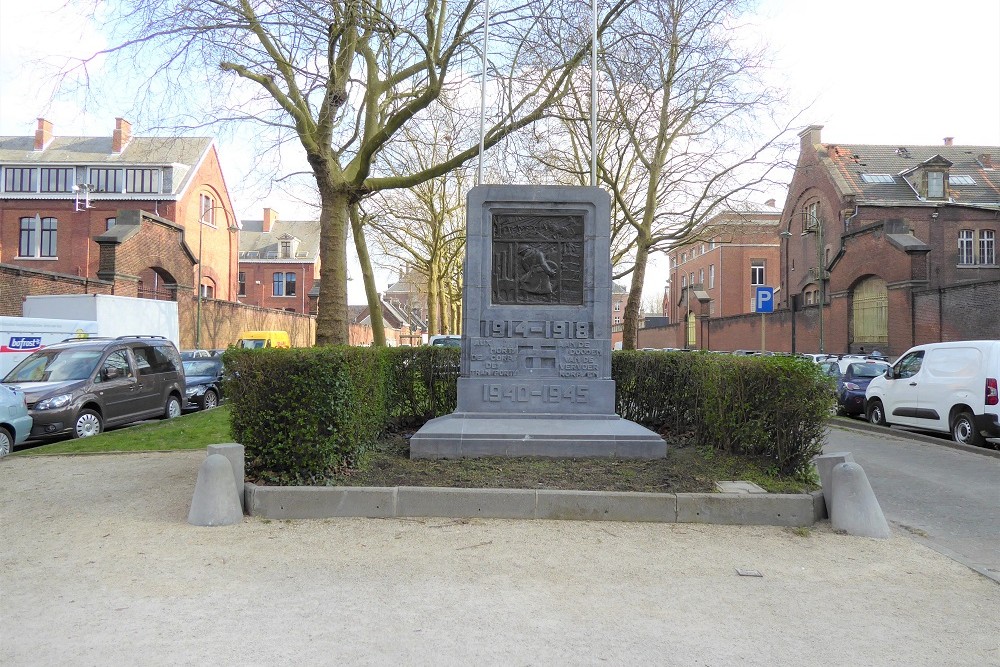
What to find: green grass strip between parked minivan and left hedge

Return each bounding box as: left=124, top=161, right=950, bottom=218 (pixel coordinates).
left=12, top=405, right=232, bottom=456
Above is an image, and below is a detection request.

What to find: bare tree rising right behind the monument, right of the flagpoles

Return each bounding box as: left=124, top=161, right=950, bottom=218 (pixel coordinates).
left=532, top=0, right=790, bottom=349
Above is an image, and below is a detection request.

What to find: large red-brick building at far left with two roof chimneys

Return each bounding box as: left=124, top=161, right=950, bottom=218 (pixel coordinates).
left=0, top=118, right=237, bottom=300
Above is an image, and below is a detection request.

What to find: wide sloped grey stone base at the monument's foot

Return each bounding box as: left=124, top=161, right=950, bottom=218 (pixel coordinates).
left=410, top=412, right=667, bottom=459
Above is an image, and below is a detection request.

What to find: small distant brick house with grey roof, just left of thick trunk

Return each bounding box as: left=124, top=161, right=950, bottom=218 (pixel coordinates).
left=238, top=208, right=320, bottom=314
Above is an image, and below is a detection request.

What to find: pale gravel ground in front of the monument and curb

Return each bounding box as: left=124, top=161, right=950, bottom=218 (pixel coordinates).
left=0, top=452, right=1000, bottom=667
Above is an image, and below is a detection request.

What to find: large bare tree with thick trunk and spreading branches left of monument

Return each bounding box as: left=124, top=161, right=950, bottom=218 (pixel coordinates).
left=74, top=0, right=635, bottom=345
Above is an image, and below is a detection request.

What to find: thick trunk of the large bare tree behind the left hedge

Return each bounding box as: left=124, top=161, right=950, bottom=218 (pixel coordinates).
left=316, top=188, right=350, bottom=345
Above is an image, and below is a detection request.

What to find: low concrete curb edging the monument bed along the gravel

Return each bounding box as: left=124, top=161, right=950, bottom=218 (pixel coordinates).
left=245, top=482, right=825, bottom=527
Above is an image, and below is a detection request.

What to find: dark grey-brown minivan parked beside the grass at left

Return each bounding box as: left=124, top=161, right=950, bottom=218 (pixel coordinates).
left=3, top=336, right=184, bottom=438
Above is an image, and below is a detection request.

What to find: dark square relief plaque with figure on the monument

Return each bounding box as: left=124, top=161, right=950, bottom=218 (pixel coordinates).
left=491, top=214, right=584, bottom=305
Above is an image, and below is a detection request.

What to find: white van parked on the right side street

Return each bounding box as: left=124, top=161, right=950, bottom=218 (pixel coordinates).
left=865, top=340, right=1000, bottom=445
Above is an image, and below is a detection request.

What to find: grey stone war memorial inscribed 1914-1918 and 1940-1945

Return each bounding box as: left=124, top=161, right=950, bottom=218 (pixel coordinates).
left=410, top=185, right=667, bottom=458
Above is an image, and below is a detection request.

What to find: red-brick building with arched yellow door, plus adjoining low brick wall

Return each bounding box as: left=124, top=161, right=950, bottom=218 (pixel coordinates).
left=639, top=125, right=1000, bottom=356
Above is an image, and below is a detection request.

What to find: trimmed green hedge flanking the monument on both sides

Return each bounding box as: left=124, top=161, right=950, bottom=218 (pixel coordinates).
left=223, top=346, right=833, bottom=484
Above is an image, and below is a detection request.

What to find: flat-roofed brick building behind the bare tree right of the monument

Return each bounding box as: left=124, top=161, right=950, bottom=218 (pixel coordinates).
left=663, top=199, right=781, bottom=348
